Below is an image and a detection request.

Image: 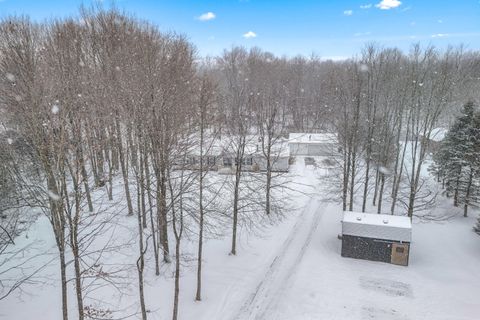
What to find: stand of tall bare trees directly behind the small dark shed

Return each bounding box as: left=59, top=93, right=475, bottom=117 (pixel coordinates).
left=330, top=45, right=478, bottom=217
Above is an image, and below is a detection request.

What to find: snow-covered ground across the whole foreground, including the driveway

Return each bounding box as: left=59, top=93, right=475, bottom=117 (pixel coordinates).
left=0, top=161, right=480, bottom=320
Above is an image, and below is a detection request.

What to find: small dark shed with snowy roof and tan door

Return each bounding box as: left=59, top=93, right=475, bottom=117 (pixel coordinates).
left=342, top=211, right=412, bottom=266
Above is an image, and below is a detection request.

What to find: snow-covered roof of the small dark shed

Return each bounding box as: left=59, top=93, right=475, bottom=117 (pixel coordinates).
left=342, top=211, right=412, bottom=242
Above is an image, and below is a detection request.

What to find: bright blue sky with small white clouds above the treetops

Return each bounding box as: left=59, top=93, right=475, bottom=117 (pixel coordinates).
left=0, top=0, right=480, bottom=58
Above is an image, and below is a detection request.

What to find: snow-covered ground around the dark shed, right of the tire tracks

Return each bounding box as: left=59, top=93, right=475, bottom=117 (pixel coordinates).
left=265, top=205, right=480, bottom=320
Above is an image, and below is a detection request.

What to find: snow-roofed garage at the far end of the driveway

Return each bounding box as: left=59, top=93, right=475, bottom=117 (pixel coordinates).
left=288, top=132, right=338, bottom=156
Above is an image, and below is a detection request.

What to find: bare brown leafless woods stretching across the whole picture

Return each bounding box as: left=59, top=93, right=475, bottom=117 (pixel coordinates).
left=0, top=6, right=480, bottom=320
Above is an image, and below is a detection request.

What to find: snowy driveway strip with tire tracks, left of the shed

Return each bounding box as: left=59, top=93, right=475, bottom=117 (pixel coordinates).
left=233, top=198, right=323, bottom=320
